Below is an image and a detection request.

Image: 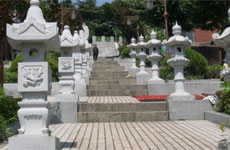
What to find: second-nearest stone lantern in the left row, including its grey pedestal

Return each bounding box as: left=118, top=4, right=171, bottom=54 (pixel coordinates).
left=52, top=25, right=79, bottom=123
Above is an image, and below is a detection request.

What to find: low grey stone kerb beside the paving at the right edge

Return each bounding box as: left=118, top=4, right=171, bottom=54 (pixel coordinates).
left=205, top=111, right=230, bottom=124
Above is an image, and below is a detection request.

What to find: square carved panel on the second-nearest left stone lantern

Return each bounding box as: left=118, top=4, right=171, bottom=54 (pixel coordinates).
left=58, top=57, right=74, bottom=73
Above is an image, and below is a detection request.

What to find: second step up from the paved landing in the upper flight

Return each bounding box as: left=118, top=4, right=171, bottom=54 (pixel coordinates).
left=87, top=84, right=147, bottom=90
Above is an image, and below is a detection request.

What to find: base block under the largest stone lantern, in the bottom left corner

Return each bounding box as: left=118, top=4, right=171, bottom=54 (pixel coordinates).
left=9, top=135, right=59, bottom=150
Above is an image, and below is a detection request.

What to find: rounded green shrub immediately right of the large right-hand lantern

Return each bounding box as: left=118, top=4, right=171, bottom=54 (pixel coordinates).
left=184, top=49, right=208, bottom=79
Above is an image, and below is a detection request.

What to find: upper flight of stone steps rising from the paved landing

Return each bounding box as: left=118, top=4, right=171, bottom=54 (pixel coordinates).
left=87, top=57, right=148, bottom=96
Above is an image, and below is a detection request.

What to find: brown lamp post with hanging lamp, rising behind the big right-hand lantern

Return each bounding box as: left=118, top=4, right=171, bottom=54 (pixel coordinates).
left=146, top=0, right=169, bottom=57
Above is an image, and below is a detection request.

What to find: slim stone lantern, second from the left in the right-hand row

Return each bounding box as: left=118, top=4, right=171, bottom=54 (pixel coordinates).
left=136, top=35, right=149, bottom=84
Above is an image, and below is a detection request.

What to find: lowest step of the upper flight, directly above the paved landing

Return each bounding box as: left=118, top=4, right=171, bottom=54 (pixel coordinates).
left=87, top=89, right=148, bottom=96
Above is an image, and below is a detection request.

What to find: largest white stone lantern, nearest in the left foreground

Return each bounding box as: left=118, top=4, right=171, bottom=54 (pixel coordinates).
left=7, top=0, right=60, bottom=150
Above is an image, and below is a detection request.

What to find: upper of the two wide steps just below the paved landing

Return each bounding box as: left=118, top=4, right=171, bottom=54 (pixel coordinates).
left=78, top=102, right=168, bottom=112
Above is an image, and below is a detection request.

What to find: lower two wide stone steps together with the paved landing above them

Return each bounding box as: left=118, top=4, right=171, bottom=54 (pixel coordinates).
left=77, top=96, right=169, bottom=123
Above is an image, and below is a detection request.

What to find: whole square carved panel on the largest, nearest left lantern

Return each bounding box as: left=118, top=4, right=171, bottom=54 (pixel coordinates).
left=18, top=62, right=49, bottom=92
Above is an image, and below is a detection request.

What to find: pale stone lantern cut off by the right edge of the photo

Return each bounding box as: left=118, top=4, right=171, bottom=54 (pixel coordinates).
left=212, top=9, right=230, bottom=82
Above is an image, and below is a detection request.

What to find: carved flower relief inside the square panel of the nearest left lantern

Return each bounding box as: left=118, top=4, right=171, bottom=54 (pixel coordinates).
left=22, top=67, right=44, bottom=87
